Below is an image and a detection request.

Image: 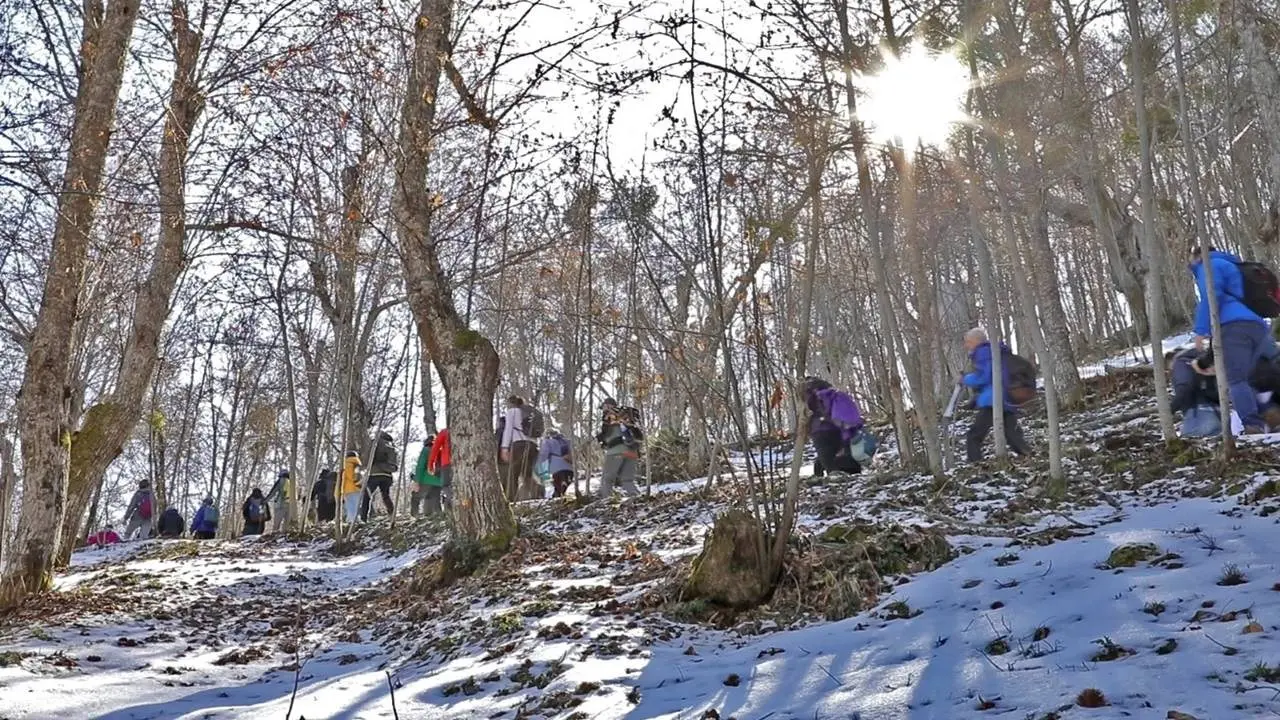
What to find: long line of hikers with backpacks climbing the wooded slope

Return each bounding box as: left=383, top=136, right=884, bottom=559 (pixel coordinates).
left=86, top=247, right=1280, bottom=547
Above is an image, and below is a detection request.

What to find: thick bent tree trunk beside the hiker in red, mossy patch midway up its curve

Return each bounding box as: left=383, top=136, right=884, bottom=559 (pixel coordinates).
left=393, top=0, right=516, bottom=543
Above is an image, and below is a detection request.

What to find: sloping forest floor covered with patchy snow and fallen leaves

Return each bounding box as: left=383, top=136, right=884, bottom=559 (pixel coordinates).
left=0, top=338, right=1280, bottom=720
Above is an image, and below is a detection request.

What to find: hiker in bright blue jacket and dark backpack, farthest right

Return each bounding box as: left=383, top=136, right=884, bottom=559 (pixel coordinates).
left=1190, top=247, right=1276, bottom=436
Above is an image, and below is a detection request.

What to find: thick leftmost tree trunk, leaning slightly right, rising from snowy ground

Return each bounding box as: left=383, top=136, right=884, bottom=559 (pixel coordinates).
left=0, top=0, right=138, bottom=607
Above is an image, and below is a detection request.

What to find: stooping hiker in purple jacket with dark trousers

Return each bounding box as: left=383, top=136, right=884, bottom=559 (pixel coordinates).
left=804, top=377, right=870, bottom=477
